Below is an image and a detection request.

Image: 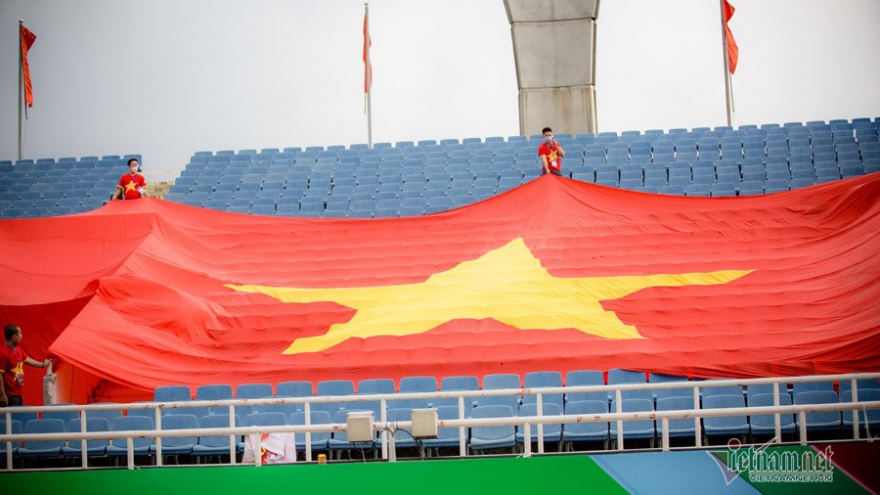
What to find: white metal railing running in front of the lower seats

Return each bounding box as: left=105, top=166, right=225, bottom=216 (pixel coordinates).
left=0, top=373, right=880, bottom=470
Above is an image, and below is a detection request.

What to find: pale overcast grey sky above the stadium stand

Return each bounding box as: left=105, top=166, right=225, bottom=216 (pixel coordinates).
left=0, top=0, right=880, bottom=180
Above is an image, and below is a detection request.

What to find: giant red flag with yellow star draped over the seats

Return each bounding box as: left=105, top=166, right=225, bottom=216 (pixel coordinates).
left=0, top=173, right=880, bottom=396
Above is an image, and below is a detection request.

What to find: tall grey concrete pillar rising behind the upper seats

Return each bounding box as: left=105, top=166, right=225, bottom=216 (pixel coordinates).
left=504, top=0, right=599, bottom=136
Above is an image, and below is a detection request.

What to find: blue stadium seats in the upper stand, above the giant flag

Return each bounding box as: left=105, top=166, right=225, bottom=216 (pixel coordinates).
left=0, top=119, right=880, bottom=218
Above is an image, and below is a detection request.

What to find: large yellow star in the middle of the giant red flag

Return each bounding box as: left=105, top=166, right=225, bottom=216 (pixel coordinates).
left=226, top=238, right=753, bottom=354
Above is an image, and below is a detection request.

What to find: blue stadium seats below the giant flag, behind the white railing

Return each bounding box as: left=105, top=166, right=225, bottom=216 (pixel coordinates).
left=0, top=369, right=880, bottom=466
